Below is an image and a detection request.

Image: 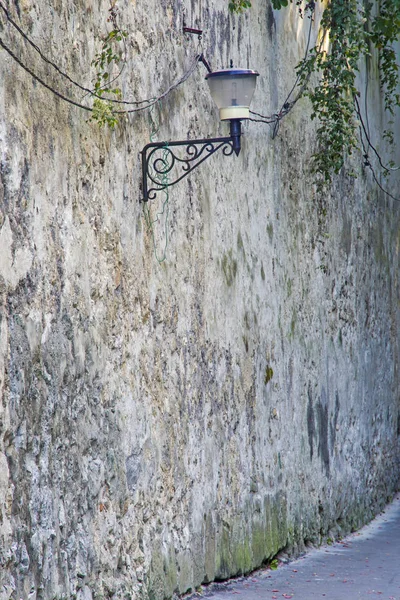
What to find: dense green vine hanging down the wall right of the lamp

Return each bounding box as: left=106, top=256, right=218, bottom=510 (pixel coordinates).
left=229, top=0, right=400, bottom=188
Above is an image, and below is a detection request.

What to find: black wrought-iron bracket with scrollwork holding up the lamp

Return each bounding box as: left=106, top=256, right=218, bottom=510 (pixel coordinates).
left=140, top=119, right=241, bottom=202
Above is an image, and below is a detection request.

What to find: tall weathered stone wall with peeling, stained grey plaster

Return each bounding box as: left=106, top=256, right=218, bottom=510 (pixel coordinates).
left=0, top=0, right=400, bottom=600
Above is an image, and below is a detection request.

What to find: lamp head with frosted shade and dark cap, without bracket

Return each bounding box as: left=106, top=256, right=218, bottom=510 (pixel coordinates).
left=206, top=69, right=259, bottom=121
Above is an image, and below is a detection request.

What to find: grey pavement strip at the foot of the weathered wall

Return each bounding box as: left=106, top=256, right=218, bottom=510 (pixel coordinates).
left=206, top=495, right=400, bottom=600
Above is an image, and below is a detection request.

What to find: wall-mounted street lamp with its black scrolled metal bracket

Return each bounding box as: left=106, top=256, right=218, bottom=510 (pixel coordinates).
left=141, top=61, right=259, bottom=202
